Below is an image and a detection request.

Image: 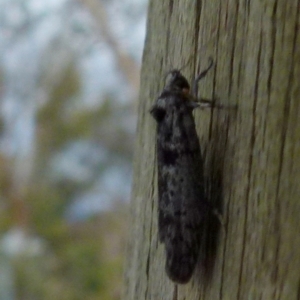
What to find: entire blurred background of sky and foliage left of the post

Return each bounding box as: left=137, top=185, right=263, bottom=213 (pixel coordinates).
left=0, top=0, right=147, bottom=300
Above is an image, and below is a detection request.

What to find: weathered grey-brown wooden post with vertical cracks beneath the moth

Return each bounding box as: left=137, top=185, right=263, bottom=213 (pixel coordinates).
left=124, top=0, right=300, bottom=300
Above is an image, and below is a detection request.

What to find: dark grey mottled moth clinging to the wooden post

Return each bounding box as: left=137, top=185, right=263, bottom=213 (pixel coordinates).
left=150, top=59, right=213, bottom=283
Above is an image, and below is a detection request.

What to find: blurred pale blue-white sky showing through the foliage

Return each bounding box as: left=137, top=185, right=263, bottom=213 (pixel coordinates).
left=0, top=0, right=146, bottom=216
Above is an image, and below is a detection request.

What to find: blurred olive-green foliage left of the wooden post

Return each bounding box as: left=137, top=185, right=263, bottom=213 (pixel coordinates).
left=0, top=58, right=132, bottom=300
